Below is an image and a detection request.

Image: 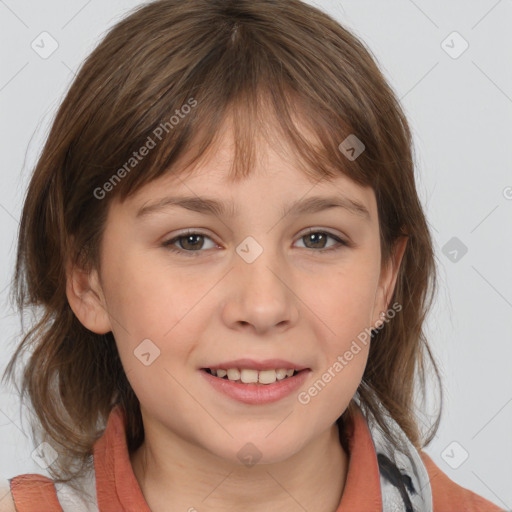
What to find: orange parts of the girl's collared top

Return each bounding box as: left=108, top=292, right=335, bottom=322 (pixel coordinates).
left=10, top=406, right=504, bottom=512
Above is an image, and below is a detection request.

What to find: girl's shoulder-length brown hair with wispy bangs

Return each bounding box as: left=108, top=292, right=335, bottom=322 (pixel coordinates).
left=3, top=0, right=442, bottom=488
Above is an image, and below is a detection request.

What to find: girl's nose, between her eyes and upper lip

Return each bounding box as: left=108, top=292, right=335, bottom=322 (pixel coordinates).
left=222, top=241, right=300, bottom=334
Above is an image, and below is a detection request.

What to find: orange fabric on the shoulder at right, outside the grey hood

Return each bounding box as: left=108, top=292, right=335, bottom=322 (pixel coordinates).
left=420, top=451, right=504, bottom=512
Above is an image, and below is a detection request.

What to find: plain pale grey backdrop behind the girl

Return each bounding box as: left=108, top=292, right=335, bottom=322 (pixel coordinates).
left=0, top=0, right=512, bottom=509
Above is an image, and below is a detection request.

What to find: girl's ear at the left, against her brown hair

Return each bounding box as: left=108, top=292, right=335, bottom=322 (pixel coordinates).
left=66, top=263, right=112, bottom=334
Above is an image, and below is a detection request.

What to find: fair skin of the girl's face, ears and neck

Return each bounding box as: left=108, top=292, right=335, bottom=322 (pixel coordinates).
left=67, top=120, right=405, bottom=512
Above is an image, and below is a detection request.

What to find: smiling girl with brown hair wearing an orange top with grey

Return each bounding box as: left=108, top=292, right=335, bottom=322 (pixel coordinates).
left=2, top=0, right=500, bottom=512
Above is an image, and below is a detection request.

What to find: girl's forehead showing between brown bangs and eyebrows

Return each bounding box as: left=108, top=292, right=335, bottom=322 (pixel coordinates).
left=116, top=112, right=376, bottom=222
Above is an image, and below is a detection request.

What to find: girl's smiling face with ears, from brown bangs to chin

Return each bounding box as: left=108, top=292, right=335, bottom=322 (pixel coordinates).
left=68, top=120, right=404, bottom=463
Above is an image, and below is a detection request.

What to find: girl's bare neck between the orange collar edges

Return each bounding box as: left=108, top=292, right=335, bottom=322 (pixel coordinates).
left=130, top=423, right=348, bottom=512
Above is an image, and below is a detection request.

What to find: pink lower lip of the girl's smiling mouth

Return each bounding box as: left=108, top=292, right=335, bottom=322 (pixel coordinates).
left=200, top=369, right=311, bottom=405
